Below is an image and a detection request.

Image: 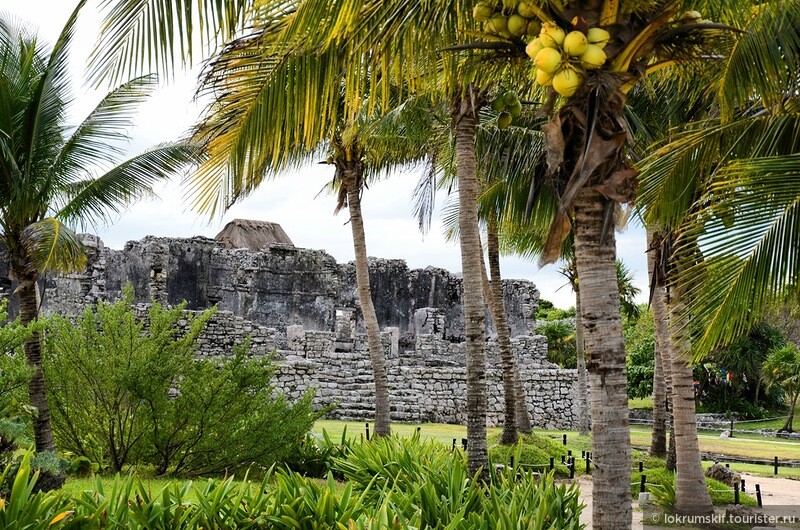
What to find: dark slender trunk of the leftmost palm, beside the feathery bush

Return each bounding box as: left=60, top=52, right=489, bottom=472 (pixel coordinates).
left=17, top=273, right=56, bottom=453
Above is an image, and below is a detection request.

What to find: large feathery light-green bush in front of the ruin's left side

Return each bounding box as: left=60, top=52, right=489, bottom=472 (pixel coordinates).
left=44, top=290, right=319, bottom=475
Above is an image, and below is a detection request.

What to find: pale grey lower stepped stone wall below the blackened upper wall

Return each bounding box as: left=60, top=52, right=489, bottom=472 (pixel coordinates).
left=187, top=308, right=577, bottom=428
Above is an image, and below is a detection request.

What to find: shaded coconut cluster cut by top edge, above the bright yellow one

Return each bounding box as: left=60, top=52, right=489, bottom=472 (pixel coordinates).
left=472, top=0, right=542, bottom=39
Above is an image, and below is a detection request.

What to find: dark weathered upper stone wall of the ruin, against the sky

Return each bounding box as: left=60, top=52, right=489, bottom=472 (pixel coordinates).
left=39, top=236, right=539, bottom=343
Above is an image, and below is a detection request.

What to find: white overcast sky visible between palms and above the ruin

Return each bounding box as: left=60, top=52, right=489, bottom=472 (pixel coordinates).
left=0, top=0, right=647, bottom=308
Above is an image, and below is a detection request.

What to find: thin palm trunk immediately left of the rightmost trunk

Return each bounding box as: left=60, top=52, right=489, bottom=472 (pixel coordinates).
left=647, top=229, right=669, bottom=458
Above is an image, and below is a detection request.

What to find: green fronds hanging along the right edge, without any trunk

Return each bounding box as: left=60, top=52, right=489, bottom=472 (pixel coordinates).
left=647, top=1, right=800, bottom=357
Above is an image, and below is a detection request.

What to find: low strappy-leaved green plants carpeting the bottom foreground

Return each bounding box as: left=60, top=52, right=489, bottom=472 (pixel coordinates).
left=0, top=437, right=583, bottom=530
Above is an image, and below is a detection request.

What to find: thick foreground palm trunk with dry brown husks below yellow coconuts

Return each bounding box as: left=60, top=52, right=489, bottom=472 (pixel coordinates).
left=506, top=0, right=744, bottom=528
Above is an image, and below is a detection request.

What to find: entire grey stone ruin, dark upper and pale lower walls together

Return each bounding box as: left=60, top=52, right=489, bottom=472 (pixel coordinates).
left=0, top=229, right=577, bottom=428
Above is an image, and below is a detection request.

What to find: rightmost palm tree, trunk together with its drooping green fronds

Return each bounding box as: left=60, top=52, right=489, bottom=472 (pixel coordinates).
left=640, top=2, right=800, bottom=509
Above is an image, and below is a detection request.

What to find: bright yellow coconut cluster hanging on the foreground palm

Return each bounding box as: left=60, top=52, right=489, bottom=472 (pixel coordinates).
left=525, top=22, right=611, bottom=97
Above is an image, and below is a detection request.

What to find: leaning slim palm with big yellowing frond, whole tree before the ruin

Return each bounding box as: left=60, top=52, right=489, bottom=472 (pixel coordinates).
left=189, top=11, right=440, bottom=436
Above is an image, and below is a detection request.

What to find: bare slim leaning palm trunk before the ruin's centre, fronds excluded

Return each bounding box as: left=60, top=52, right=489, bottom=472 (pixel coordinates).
left=342, top=160, right=391, bottom=436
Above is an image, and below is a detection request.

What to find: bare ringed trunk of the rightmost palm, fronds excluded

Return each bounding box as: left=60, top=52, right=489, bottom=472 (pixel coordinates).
left=669, top=287, right=713, bottom=514
